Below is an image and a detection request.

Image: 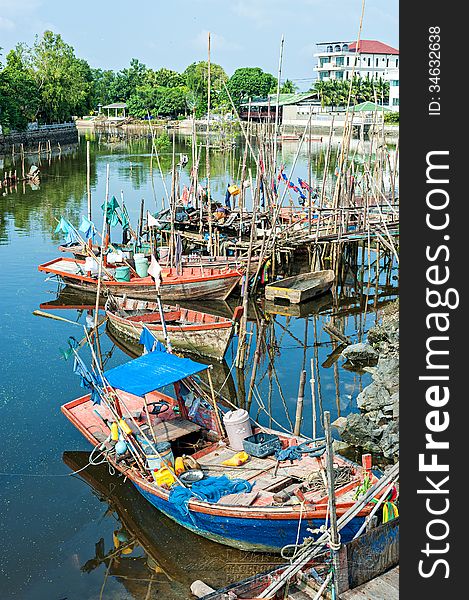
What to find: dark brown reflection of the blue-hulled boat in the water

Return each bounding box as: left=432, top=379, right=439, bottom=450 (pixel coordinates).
left=63, top=452, right=279, bottom=600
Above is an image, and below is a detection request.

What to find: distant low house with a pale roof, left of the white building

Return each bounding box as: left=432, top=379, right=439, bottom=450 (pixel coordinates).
left=239, top=92, right=321, bottom=124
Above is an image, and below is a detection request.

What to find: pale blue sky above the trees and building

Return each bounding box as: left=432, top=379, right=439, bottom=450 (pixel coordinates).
left=0, top=0, right=399, bottom=89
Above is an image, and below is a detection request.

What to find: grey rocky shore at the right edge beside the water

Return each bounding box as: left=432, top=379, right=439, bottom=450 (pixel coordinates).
left=334, top=302, right=399, bottom=459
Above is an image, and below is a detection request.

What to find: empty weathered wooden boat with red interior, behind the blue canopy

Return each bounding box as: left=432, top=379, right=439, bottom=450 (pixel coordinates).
left=105, top=296, right=242, bottom=360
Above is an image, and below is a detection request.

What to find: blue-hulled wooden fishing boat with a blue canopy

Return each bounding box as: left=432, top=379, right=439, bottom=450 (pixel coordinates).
left=62, top=352, right=382, bottom=553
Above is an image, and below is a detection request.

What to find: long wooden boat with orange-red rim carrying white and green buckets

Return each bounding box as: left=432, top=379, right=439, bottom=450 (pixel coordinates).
left=38, top=258, right=241, bottom=301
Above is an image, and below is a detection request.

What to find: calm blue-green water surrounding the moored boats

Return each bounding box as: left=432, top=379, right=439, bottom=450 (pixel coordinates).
left=0, top=137, right=394, bottom=600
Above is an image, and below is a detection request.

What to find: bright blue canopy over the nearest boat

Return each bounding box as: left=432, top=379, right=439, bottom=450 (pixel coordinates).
left=104, top=352, right=208, bottom=396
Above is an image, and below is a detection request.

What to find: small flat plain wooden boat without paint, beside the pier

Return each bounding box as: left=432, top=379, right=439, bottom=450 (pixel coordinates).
left=265, top=269, right=335, bottom=304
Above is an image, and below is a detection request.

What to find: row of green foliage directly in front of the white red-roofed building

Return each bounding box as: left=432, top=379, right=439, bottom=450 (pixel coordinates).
left=312, top=77, right=389, bottom=108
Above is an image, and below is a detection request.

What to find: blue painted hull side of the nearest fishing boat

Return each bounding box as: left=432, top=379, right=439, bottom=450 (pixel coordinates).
left=134, top=483, right=365, bottom=553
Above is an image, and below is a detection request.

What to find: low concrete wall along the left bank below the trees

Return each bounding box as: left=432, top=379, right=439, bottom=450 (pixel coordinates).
left=0, top=123, right=78, bottom=154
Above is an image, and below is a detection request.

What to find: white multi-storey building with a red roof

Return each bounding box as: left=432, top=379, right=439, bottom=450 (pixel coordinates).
left=314, top=40, right=399, bottom=81
